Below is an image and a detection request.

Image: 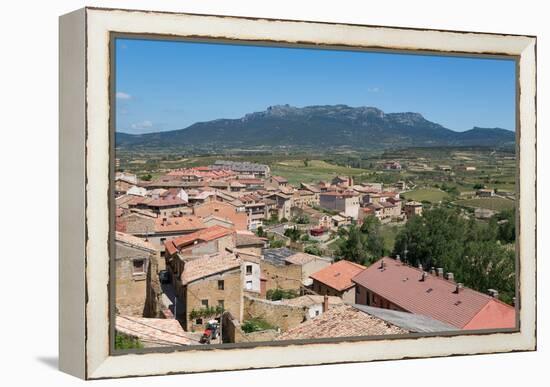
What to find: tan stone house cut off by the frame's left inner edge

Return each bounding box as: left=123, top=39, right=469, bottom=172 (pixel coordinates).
left=115, top=231, right=158, bottom=316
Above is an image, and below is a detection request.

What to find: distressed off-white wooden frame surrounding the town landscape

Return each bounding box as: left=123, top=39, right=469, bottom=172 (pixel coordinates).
left=59, top=8, right=536, bottom=379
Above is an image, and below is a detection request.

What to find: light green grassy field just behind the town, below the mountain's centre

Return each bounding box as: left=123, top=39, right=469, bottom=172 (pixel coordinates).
left=271, top=160, right=369, bottom=184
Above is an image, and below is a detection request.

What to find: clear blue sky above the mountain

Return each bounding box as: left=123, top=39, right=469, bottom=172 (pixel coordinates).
left=116, top=39, right=515, bottom=134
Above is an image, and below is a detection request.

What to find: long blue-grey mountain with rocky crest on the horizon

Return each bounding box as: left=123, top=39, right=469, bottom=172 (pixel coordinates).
left=116, top=105, right=515, bottom=149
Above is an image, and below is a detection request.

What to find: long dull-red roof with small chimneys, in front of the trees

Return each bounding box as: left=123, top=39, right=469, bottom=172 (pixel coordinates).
left=352, top=257, right=515, bottom=329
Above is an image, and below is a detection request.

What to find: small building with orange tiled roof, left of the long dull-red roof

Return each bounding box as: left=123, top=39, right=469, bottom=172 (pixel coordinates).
left=310, top=260, right=366, bottom=303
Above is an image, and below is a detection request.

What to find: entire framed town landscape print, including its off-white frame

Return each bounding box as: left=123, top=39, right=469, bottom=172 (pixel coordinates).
left=60, top=8, right=536, bottom=379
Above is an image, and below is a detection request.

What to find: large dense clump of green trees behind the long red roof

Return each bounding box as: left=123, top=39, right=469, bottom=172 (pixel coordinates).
left=393, top=208, right=515, bottom=303
